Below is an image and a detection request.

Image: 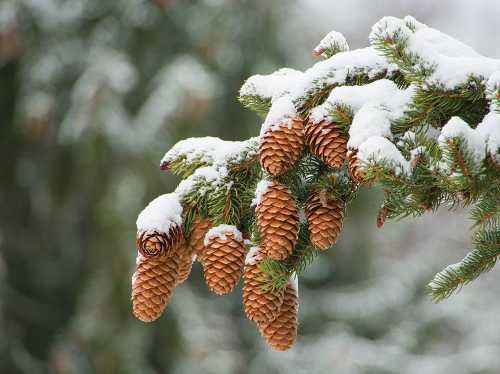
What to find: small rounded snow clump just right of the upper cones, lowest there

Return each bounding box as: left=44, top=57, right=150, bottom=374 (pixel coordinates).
left=357, top=136, right=410, bottom=175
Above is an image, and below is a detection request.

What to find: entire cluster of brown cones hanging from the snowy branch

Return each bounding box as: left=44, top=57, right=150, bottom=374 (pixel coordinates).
left=132, top=118, right=357, bottom=350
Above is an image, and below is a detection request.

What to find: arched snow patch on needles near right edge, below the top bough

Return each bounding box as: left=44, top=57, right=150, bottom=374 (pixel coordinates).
left=438, top=117, right=486, bottom=162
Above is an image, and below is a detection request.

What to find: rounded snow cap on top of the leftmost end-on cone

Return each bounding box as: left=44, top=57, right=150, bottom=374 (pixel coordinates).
left=136, top=193, right=182, bottom=233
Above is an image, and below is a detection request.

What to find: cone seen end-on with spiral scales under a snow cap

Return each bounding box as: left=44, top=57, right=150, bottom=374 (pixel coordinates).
left=136, top=225, right=184, bottom=257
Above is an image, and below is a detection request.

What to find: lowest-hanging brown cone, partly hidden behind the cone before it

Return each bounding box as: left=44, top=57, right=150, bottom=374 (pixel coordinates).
left=259, top=283, right=299, bottom=351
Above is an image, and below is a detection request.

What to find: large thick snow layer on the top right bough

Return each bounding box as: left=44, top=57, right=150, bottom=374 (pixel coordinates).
left=370, top=17, right=500, bottom=89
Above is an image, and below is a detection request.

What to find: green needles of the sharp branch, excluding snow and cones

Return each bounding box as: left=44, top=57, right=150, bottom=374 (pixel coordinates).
left=171, top=18, right=500, bottom=301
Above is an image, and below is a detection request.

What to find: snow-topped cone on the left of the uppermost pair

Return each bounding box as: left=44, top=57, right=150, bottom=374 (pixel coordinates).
left=259, top=117, right=304, bottom=176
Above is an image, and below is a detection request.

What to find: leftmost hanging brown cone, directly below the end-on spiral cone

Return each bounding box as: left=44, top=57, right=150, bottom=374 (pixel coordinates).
left=132, top=254, right=179, bottom=322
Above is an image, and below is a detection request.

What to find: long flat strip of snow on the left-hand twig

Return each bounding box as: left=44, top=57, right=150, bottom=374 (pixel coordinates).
left=161, top=136, right=256, bottom=165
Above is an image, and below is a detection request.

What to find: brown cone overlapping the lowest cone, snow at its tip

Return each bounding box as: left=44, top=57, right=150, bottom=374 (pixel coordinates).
left=243, top=247, right=284, bottom=322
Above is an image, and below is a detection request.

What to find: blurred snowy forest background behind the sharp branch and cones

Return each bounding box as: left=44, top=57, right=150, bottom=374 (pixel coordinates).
left=0, top=0, right=500, bottom=374
